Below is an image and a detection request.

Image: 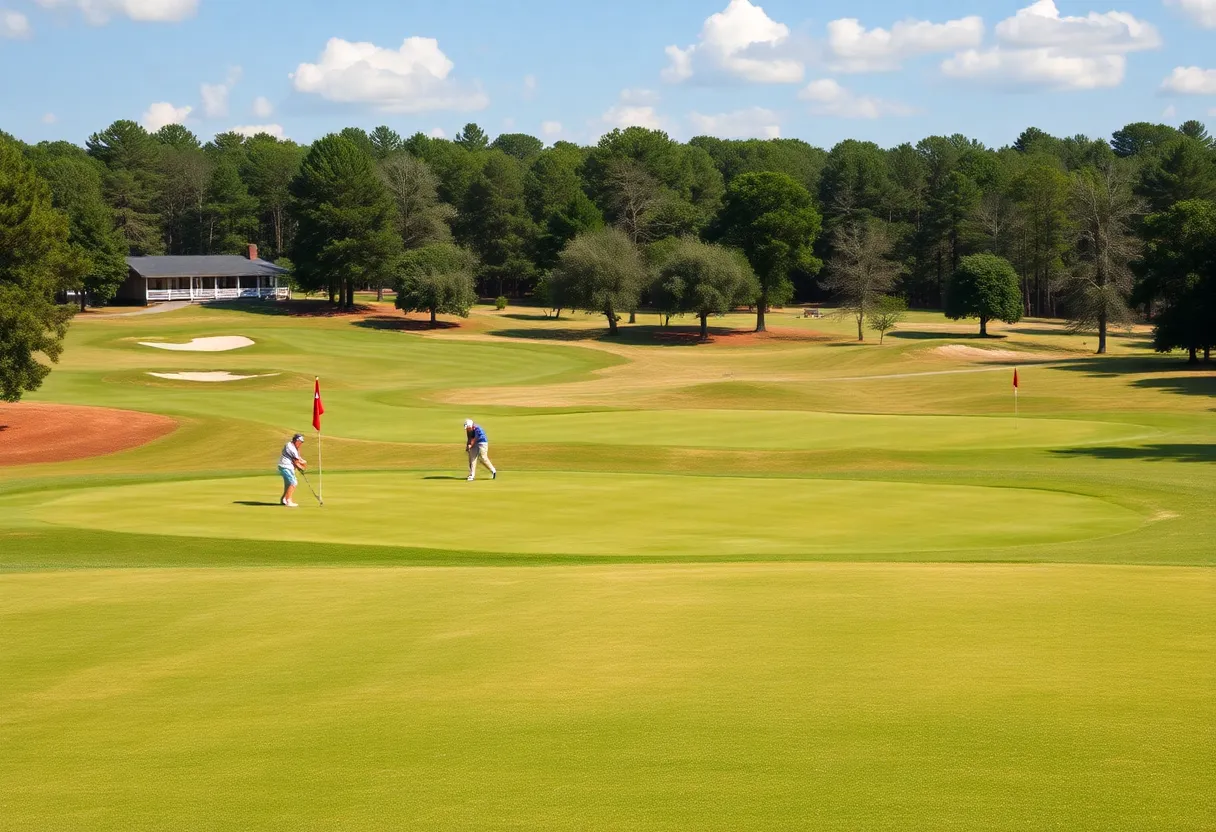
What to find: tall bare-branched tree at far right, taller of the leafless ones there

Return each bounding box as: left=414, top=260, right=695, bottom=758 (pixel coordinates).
left=1069, top=164, right=1145, bottom=355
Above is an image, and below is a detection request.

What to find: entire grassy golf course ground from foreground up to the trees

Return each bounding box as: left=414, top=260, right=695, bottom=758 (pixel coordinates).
left=0, top=304, right=1216, bottom=832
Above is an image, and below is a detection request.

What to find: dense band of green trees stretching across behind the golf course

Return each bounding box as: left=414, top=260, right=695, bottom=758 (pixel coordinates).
left=0, top=120, right=1216, bottom=398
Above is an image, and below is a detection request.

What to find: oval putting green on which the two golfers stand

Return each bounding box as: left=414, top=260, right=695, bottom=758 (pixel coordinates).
left=34, top=472, right=1142, bottom=557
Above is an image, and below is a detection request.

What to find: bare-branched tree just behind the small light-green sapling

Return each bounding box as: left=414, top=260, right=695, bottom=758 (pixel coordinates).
left=820, top=220, right=903, bottom=341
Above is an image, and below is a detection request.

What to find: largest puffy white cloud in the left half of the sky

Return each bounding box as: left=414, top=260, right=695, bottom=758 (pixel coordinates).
left=291, top=38, right=490, bottom=113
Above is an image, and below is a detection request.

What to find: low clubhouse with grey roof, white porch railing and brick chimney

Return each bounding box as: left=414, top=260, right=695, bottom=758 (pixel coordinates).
left=118, top=246, right=291, bottom=305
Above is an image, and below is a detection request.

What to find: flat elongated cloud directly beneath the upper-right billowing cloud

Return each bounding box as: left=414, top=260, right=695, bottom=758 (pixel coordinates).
left=941, top=46, right=1127, bottom=90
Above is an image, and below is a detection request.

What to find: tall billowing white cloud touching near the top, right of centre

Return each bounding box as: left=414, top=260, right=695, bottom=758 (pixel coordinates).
left=663, top=0, right=804, bottom=84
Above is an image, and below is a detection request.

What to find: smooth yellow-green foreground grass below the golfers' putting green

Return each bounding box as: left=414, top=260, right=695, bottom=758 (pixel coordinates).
left=0, top=564, right=1216, bottom=832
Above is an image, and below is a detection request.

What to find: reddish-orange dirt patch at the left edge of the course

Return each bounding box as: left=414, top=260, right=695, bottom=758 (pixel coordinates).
left=0, top=404, right=178, bottom=466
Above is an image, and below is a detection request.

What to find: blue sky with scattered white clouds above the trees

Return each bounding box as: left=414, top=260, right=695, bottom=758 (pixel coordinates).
left=0, top=0, right=1216, bottom=146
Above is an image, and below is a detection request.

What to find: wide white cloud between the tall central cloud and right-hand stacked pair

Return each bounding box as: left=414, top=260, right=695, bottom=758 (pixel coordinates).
left=828, top=16, right=984, bottom=72
